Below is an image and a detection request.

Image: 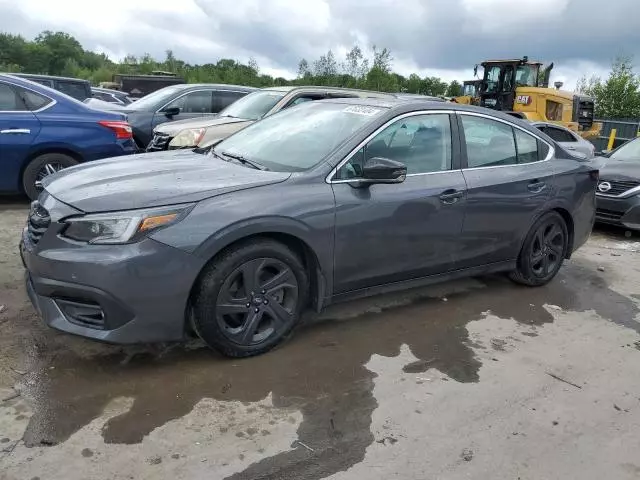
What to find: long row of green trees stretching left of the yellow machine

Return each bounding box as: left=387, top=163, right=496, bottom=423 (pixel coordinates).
left=0, top=30, right=462, bottom=96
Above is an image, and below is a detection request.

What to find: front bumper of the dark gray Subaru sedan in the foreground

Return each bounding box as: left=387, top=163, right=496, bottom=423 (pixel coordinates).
left=20, top=216, right=202, bottom=344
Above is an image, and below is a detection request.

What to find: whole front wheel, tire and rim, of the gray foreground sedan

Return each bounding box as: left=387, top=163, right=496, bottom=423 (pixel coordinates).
left=192, top=239, right=309, bottom=357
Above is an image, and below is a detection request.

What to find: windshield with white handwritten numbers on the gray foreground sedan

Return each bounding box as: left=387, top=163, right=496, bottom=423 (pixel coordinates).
left=213, top=102, right=386, bottom=172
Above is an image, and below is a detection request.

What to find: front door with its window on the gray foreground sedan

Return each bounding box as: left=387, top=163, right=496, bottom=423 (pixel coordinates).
left=331, top=113, right=466, bottom=293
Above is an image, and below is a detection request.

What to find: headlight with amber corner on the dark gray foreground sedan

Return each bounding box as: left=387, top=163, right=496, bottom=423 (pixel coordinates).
left=61, top=204, right=193, bottom=244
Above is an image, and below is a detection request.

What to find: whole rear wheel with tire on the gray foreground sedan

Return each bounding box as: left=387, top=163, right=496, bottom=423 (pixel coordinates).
left=509, top=212, right=569, bottom=287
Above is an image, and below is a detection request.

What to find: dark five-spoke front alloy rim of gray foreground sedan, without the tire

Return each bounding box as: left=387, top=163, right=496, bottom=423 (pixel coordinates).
left=216, top=258, right=298, bottom=346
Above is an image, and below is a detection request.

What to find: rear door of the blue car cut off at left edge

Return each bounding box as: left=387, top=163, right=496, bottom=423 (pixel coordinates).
left=0, top=81, right=42, bottom=192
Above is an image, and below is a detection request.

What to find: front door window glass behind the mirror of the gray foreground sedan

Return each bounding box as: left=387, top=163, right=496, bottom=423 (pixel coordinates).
left=334, top=113, right=451, bottom=180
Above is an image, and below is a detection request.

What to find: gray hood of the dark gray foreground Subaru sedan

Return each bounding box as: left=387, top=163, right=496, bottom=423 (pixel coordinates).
left=43, top=150, right=291, bottom=212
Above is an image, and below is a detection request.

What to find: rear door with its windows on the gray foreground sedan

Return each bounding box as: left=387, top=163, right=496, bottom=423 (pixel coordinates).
left=458, top=112, right=553, bottom=268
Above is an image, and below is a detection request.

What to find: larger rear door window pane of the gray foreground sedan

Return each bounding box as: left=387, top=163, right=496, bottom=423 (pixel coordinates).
left=461, top=115, right=517, bottom=168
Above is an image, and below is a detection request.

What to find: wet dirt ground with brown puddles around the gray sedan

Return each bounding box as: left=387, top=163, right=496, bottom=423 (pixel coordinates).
left=0, top=198, right=640, bottom=480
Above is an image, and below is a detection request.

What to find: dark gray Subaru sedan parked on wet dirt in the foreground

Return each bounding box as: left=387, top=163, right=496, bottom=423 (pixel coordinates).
left=21, top=99, right=598, bottom=357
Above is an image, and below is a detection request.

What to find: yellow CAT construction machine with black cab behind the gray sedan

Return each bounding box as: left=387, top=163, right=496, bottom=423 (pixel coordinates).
left=453, top=57, right=602, bottom=139
